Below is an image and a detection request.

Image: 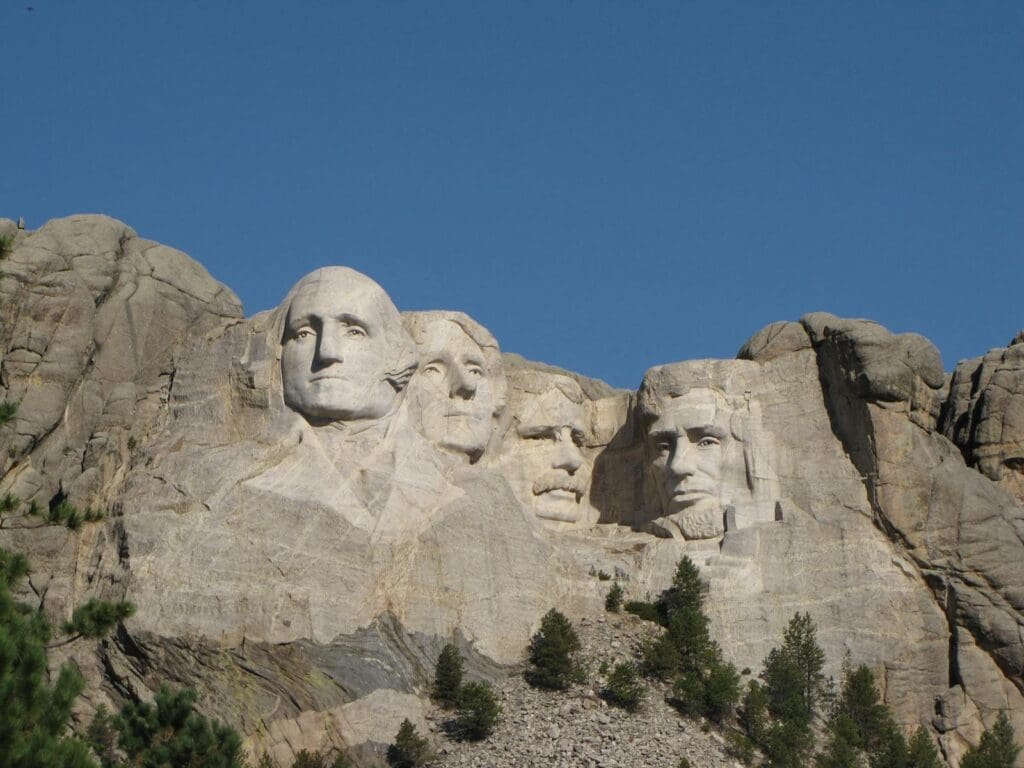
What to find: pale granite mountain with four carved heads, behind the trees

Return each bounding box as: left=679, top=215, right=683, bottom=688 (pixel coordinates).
left=0, top=215, right=1024, bottom=760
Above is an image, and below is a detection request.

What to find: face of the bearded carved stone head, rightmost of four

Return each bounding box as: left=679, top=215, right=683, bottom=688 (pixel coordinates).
left=647, top=389, right=731, bottom=518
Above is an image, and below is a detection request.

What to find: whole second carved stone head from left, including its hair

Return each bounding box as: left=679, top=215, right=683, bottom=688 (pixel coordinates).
left=406, top=312, right=505, bottom=463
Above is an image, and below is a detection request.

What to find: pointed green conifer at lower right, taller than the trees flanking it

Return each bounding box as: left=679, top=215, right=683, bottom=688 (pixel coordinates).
left=761, top=613, right=825, bottom=724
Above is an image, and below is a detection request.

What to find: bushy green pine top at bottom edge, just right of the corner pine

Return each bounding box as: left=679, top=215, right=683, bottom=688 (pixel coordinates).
left=114, top=685, right=244, bottom=768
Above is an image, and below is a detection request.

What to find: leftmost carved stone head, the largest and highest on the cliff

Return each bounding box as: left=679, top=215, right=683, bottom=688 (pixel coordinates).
left=281, top=267, right=400, bottom=424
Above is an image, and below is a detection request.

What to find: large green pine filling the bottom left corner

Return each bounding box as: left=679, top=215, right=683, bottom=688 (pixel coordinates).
left=0, top=549, right=95, bottom=768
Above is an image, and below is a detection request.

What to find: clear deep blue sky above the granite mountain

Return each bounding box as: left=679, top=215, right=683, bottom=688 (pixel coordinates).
left=0, top=0, right=1024, bottom=387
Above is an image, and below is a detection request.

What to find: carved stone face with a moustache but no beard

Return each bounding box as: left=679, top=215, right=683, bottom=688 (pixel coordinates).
left=503, top=382, right=590, bottom=522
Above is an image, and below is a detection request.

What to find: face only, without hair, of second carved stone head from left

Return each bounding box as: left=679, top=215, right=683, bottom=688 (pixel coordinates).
left=409, top=319, right=495, bottom=461
